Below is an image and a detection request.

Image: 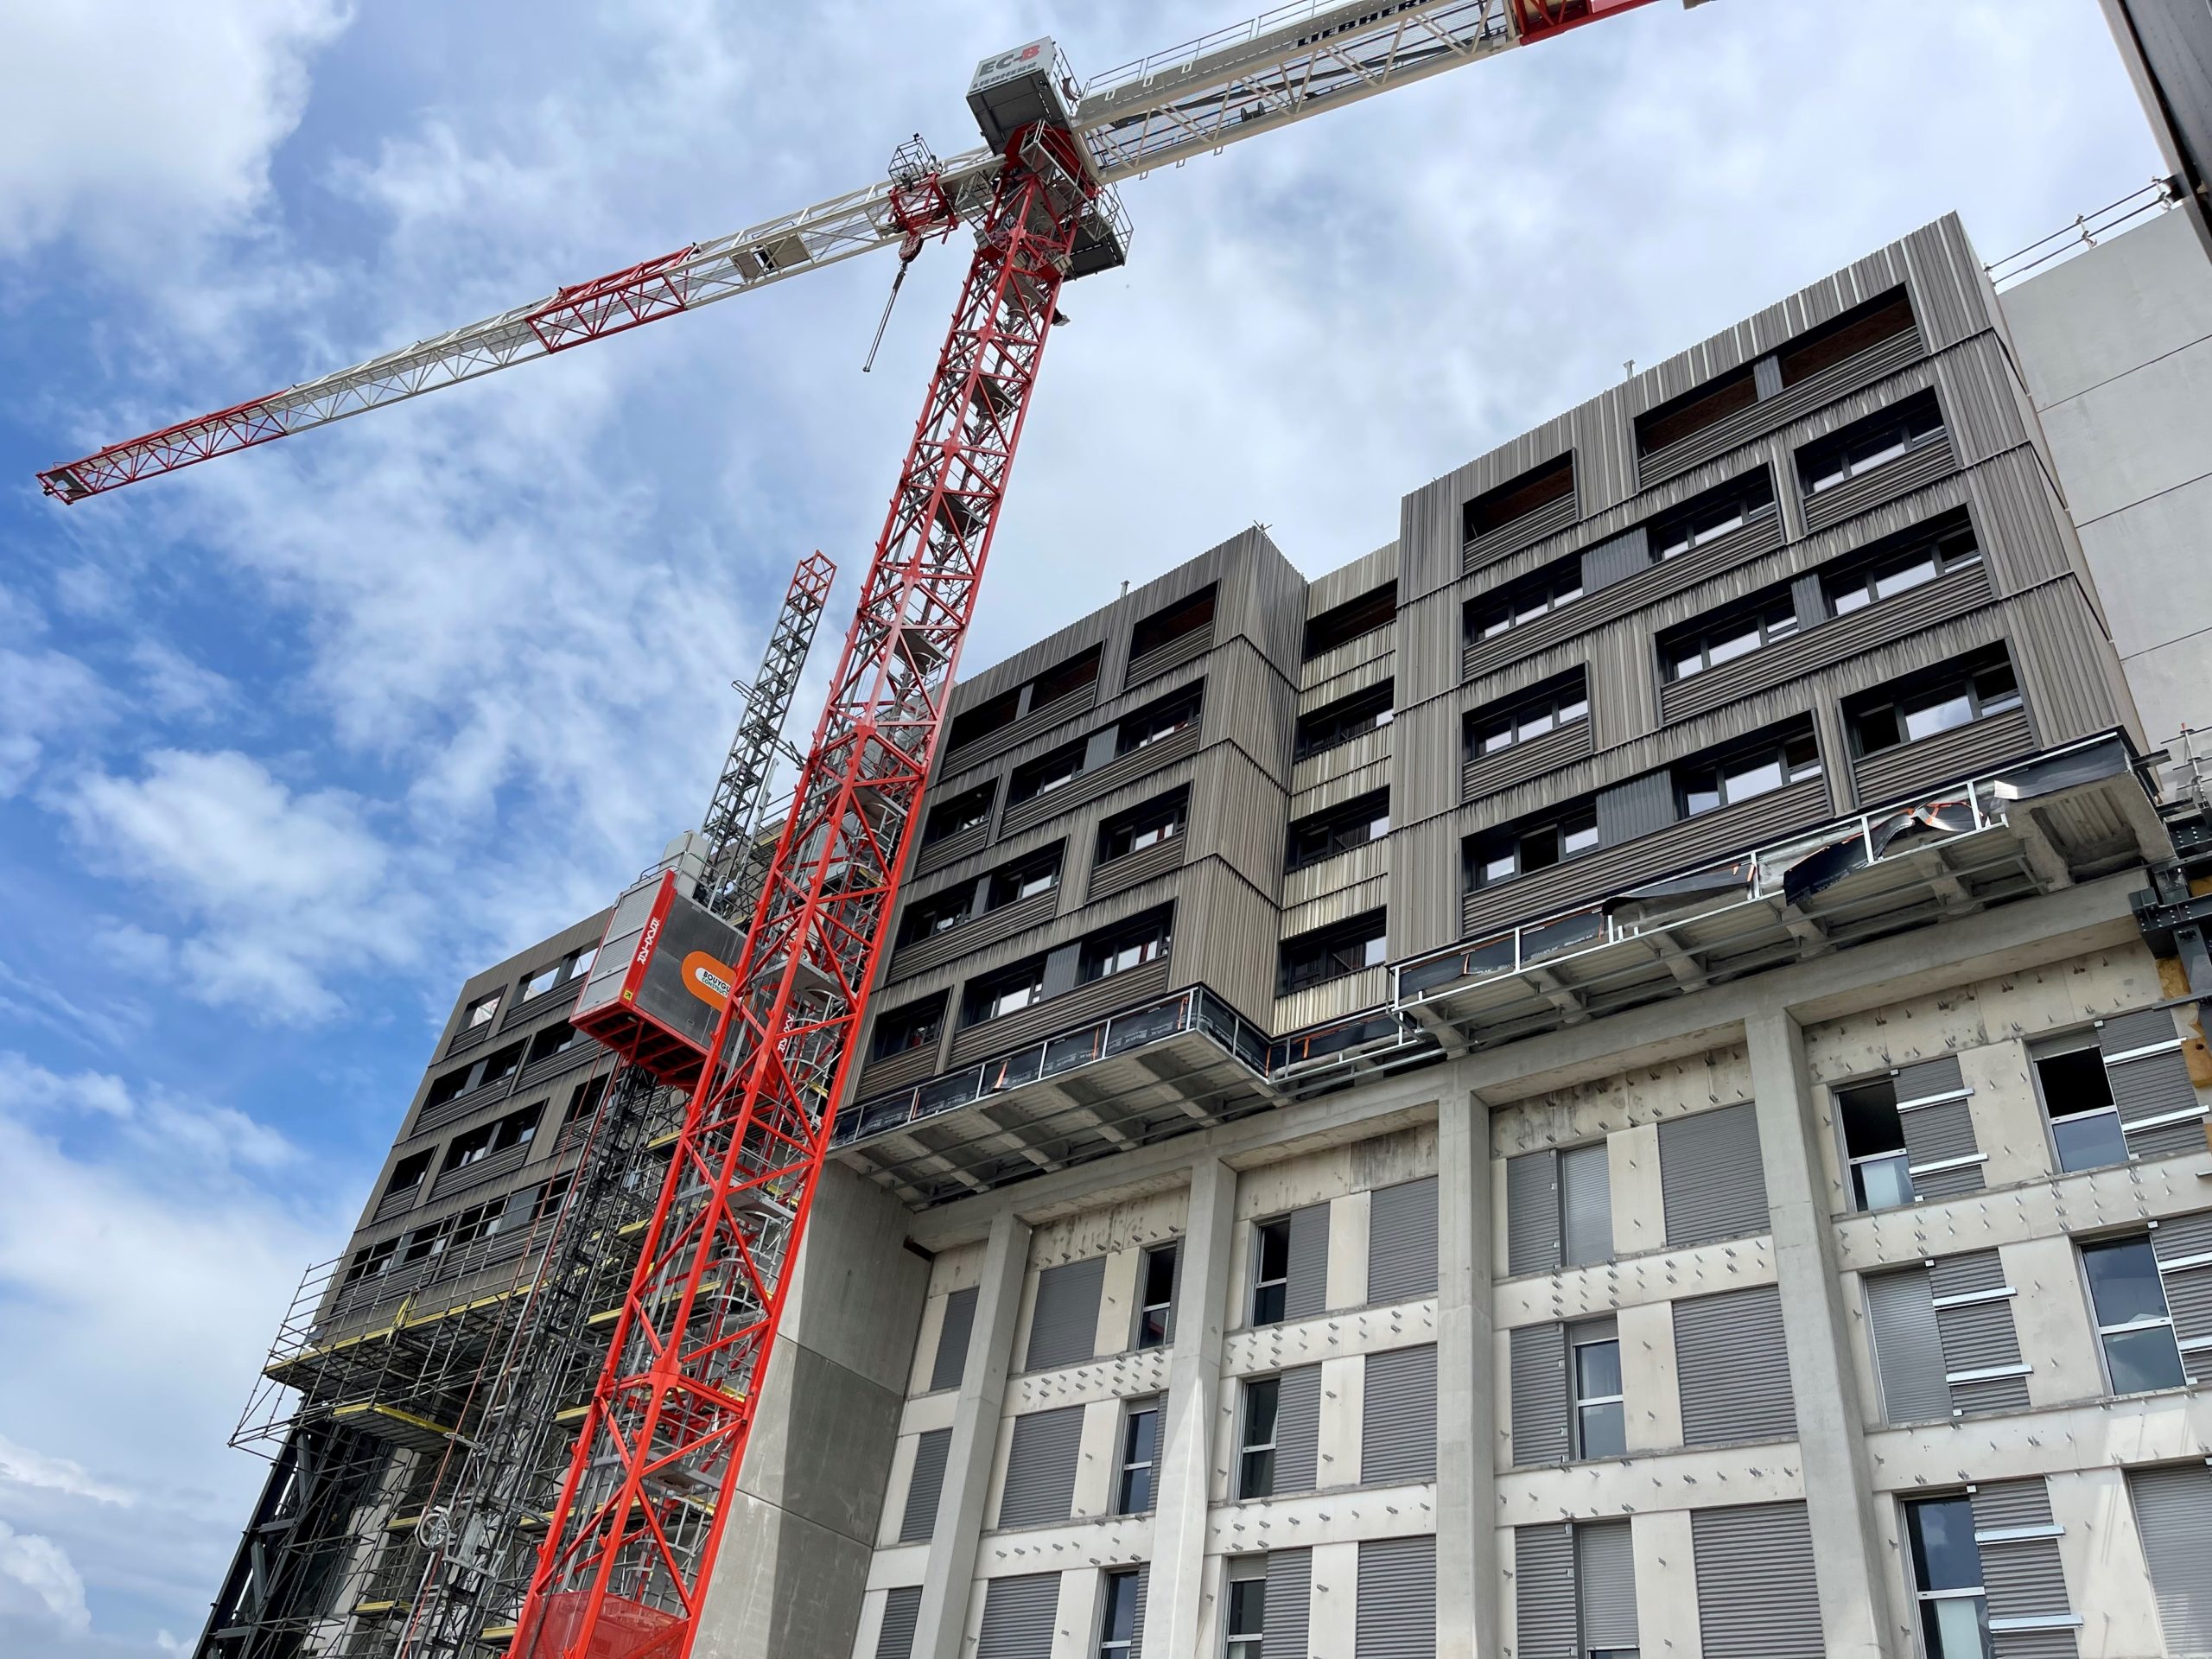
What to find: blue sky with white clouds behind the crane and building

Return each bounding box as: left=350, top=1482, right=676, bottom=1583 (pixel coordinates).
left=0, top=0, right=2157, bottom=1659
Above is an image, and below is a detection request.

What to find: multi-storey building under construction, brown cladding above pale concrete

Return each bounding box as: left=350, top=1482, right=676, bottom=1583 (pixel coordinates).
left=199, top=179, right=2212, bottom=1659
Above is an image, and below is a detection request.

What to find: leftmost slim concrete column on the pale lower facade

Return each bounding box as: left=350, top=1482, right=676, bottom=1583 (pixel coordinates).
left=913, top=1212, right=1028, bottom=1659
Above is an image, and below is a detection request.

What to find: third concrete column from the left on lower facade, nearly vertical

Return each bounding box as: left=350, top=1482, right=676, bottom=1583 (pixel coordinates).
left=1435, top=1093, right=1504, bottom=1659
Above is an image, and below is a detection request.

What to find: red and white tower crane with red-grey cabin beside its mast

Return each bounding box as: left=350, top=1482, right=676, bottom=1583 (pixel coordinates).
left=40, top=0, right=1701, bottom=1659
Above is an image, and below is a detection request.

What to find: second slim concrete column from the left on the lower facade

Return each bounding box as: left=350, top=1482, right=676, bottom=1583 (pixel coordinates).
left=1144, top=1157, right=1236, bottom=1652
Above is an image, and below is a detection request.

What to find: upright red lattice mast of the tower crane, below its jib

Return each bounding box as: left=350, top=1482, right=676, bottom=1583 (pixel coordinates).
left=513, top=128, right=1093, bottom=1659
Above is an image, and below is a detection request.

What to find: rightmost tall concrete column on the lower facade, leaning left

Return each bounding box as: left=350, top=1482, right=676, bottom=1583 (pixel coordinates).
left=1745, top=1011, right=1891, bottom=1659
